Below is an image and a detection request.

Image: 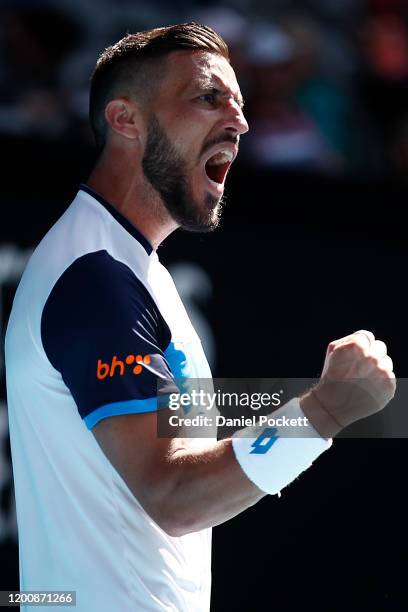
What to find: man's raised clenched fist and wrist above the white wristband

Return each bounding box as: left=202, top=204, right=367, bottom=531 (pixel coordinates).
left=300, top=330, right=396, bottom=438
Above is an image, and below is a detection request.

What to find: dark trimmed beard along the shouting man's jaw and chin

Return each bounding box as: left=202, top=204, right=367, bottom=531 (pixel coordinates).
left=142, top=116, right=224, bottom=232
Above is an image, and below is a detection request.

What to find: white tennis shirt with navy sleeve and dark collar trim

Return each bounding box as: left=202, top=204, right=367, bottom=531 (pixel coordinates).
left=6, top=186, right=213, bottom=612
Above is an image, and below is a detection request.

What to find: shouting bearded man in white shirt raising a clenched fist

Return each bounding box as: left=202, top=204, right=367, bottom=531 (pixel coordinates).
left=6, top=24, right=395, bottom=612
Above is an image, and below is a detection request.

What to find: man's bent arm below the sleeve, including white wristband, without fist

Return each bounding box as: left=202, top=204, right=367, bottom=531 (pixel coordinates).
left=99, top=399, right=330, bottom=536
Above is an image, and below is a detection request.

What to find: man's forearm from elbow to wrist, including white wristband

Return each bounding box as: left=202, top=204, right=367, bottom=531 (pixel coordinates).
left=155, top=398, right=332, bottom=533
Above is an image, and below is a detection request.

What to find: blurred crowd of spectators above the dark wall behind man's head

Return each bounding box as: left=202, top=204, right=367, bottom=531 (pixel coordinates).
left=0, top=0, right=408, bottom=177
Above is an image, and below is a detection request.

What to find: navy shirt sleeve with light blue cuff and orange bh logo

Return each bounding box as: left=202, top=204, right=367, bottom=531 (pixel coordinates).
left=41, top=251, right=176, bottom=429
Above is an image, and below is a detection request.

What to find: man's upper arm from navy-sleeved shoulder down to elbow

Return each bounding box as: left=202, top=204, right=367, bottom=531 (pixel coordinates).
left=41, top=251, right=182, bottom=518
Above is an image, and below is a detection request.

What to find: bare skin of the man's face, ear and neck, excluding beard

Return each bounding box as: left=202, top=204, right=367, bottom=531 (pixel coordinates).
left=88, top=51, right=248, bottom=248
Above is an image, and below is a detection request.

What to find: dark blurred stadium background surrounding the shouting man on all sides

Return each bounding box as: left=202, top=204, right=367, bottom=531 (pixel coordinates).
left=0, top=0, right=408, bottom=612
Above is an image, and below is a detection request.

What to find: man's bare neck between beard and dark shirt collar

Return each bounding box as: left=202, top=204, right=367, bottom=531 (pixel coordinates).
left=87, top=151, right=178, bottom=249
